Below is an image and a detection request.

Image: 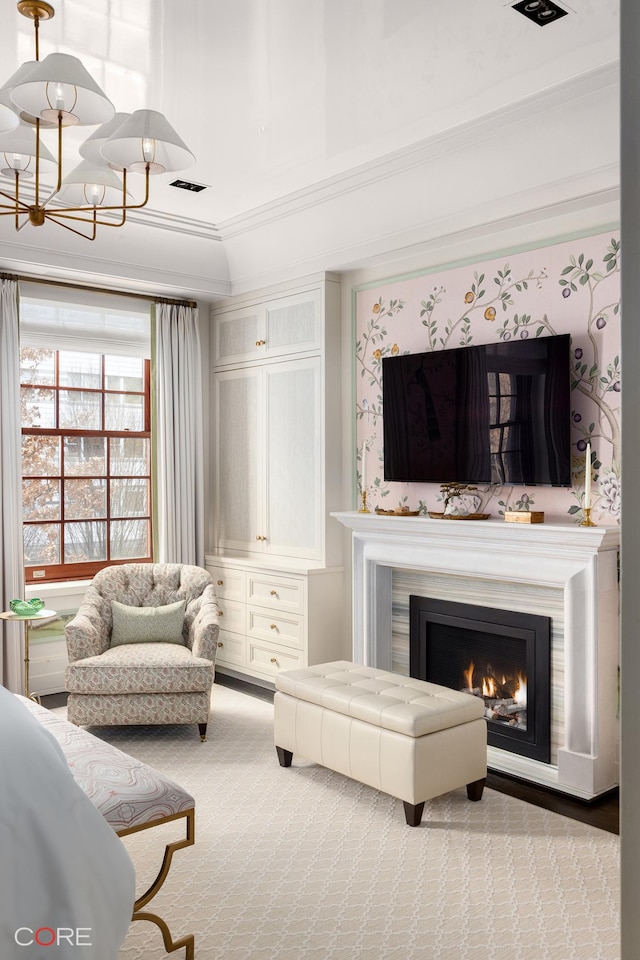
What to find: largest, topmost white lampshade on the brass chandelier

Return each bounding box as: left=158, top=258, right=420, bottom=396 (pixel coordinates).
left=10, top=53, right=115, bottom=126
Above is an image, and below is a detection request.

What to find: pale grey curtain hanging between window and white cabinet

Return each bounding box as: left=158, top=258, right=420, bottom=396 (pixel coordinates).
left=151, top=303, right=204, bottom=566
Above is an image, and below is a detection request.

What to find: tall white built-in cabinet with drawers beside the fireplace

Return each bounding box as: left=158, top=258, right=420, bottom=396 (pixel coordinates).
left=207, top=274, right=348, bottom=680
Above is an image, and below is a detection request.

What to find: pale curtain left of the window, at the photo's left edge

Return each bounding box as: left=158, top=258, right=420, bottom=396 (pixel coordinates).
left=0, top=279, right=24, bottom=693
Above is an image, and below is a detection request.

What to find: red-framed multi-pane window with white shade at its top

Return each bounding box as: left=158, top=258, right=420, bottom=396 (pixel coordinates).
left=20, top=288, right=153, bottom=583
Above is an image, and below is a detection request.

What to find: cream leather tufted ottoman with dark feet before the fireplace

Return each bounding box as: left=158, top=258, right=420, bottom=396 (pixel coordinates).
left=274, top=660, right=487, bottom=827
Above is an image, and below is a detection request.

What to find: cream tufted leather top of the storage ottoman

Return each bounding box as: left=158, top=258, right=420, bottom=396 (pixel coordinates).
left=276, top=660, right=484, bottom=737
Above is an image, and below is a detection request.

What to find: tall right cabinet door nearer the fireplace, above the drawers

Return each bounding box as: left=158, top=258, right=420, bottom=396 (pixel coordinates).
left=264, top=357, right=323, bottom=559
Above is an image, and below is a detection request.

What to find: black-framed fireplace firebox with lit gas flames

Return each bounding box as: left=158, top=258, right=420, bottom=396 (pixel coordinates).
left=409, top=596, right=551, bottom=763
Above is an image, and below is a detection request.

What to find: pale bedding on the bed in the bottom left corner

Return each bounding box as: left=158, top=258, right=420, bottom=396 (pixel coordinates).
left=0, top=687, right=135, bottom=960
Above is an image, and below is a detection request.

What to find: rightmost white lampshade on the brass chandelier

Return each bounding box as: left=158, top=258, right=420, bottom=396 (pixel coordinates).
left=101, top=110, right=195, bottom=173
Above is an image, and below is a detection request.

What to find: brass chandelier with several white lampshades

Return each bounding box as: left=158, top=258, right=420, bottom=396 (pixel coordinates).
left=0, top=0, right=195, bottom=240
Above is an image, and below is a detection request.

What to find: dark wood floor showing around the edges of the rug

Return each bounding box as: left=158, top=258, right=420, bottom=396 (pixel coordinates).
left=42, top=673, right=620, bottom=833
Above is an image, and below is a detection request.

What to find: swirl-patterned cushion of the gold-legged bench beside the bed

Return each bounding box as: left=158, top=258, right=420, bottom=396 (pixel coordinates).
left=18, top=697, right=195, bottom=832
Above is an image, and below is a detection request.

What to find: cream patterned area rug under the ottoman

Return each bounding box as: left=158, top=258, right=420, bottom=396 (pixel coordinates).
left=61, top=685, right=620, bottom=960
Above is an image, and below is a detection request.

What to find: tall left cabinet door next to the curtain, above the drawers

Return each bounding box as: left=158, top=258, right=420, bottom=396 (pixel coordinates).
left=214, top=367, right=266, bottom=551
